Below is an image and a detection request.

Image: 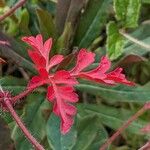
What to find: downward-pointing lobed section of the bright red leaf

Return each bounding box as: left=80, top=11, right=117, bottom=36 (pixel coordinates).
left=47, top=80, right=78, bottom=134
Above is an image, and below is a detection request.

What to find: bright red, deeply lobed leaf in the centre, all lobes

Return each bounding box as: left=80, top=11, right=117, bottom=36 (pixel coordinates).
left=22, top=35, right=134, bottom=134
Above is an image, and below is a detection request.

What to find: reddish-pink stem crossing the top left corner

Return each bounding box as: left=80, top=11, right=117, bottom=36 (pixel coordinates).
left=0, top=0, right=27, bottom=21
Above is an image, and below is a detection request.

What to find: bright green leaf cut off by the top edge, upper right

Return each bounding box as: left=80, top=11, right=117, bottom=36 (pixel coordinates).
left=114, top=0, right=141, bottom=28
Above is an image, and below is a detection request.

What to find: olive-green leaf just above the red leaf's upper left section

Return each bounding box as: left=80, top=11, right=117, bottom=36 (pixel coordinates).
left=36, top=9, right=56, bottom=39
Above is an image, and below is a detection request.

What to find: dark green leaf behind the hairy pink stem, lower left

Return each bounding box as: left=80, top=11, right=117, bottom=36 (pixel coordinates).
left=12, top=93, right=46, bottom=150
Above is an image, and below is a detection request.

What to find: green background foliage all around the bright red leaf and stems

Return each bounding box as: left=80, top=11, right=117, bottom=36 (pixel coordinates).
left=0, top=0, right=150, bottom=150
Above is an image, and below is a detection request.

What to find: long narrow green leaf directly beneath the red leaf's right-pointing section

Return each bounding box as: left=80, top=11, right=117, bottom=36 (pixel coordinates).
left=76, top=84, right=150, bottom=104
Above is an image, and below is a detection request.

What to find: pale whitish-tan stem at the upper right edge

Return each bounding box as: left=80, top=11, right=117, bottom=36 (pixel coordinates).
left=119, top=30, right=150, bottom=51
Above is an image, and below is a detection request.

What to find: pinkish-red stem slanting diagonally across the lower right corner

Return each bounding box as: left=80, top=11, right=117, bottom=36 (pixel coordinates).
left=99, top=105, right=148, bottom=150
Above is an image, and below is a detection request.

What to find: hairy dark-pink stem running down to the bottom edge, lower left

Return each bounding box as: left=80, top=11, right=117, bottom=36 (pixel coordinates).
left=4, top=98, right=45, bottom=150
